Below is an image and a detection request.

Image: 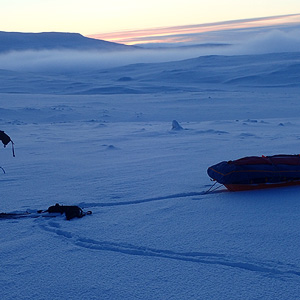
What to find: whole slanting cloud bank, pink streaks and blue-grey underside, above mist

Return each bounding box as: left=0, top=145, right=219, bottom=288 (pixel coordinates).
left=90, top=14, right=300, bottom=47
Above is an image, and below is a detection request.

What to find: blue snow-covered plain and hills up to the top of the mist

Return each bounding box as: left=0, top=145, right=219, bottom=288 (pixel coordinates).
left=0, top=20, right=300, bottom=300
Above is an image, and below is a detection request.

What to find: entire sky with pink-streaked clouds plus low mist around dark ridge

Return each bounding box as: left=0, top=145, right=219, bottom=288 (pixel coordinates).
left=0, top=0, right=300, bottom=71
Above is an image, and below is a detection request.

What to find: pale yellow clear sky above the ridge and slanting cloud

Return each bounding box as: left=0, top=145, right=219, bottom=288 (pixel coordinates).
left=0, top=0, right=300, bottom=40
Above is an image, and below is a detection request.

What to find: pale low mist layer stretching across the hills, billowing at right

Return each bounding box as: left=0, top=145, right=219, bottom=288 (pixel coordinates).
left=0, top=29, right=300, bottom=72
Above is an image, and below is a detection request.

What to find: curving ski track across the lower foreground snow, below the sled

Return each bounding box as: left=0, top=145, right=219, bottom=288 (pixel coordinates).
left=36, top=218, right=300, bottom=280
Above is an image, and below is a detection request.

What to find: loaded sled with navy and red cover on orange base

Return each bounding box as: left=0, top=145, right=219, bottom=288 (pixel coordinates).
left=207, top=154, right=300, bottom=191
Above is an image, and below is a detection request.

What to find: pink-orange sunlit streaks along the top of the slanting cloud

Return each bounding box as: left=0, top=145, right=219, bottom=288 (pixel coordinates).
left=88, top=14, right=300, bottom=45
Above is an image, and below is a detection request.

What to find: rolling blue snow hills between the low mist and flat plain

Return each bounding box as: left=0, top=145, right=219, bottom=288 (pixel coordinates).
left=0, top=52, right=300, bottom=95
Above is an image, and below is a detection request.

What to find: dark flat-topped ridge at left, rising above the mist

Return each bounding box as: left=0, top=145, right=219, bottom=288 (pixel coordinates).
left=0, top=31, right=137, bottom=52
